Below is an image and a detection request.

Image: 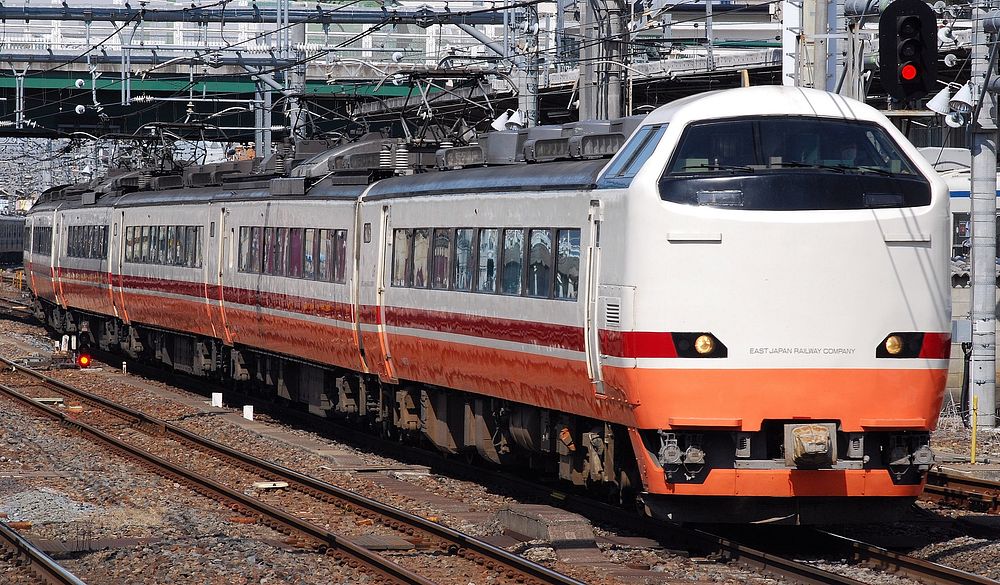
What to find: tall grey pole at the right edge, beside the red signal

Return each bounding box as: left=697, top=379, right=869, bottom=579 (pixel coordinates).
left=969, top=8, right=1000, bottom=427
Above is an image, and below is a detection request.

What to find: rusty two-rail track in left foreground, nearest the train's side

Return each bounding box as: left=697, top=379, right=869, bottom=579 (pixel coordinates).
left=0, top=358, right=580, bottom=585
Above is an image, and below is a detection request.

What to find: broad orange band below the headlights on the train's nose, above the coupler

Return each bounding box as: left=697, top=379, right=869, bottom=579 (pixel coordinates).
left=604, top=367, right=948, bottom=432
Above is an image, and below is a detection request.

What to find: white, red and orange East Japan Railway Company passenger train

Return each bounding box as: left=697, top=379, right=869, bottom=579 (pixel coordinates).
left=24, top=86, right=951, bottom=524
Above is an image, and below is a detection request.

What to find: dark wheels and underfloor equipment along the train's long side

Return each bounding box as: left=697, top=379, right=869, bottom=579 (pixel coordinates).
left=34, top=300, right=642, bottom=505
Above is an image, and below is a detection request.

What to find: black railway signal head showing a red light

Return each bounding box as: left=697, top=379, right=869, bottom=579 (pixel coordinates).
left=878, top=0, right=937, bottom=101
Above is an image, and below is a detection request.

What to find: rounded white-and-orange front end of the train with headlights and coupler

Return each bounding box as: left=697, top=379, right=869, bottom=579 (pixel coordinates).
left=599, top=87, right=951, bottom=523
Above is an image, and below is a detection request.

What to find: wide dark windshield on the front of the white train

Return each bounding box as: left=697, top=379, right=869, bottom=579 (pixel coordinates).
left=660, top=116, right=930, bottom=210
